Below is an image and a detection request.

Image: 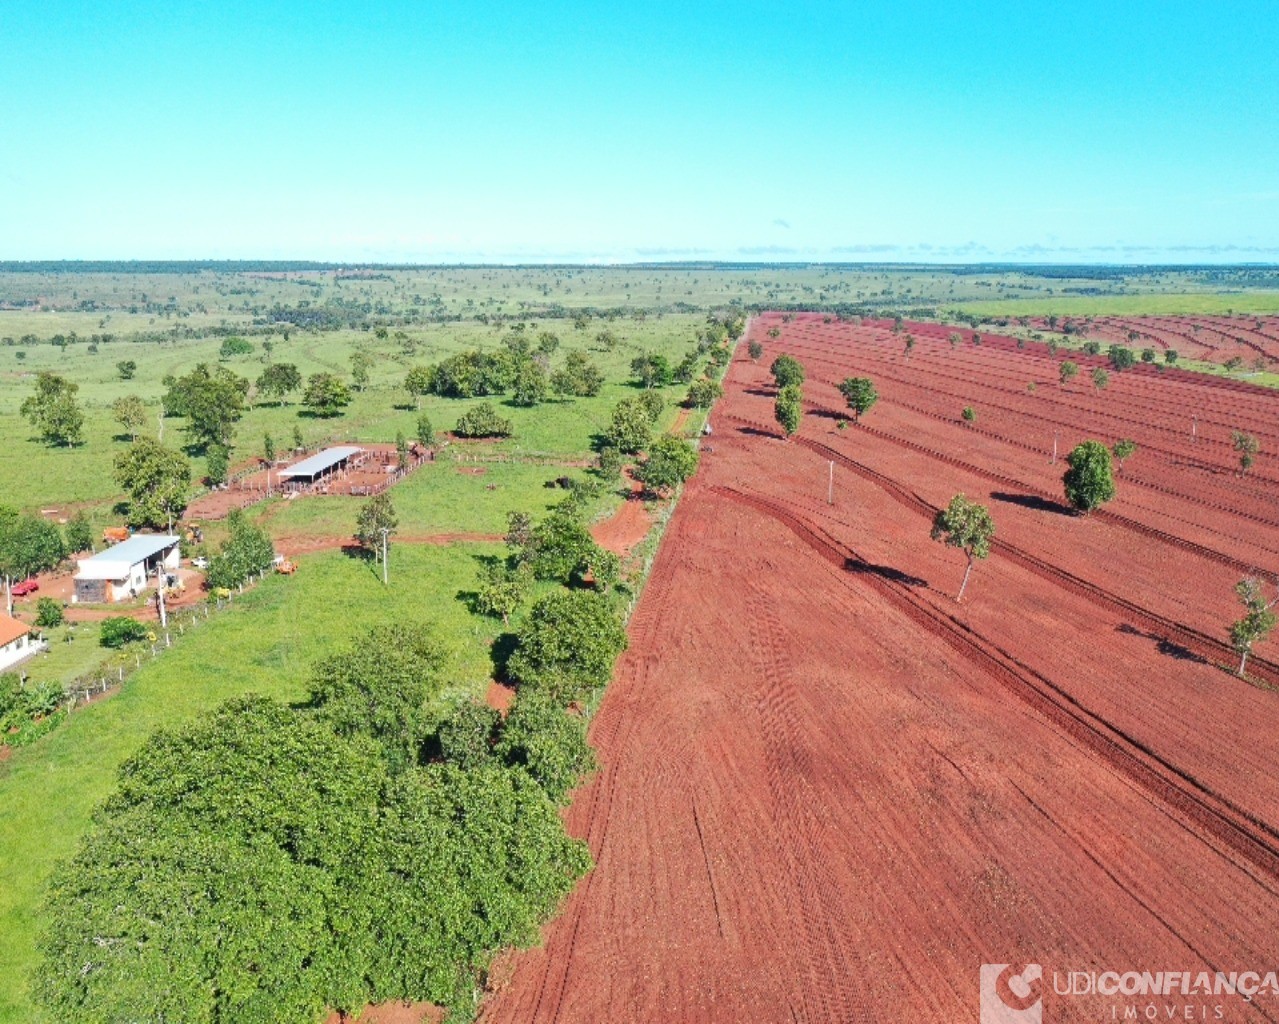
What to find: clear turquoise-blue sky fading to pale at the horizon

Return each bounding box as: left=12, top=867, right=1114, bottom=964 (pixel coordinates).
left=0, top=0, right=1279, bottom=262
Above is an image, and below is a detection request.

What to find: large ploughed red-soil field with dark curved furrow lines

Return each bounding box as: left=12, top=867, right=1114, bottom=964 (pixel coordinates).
left=481, top=314, right=1279, bottom=1024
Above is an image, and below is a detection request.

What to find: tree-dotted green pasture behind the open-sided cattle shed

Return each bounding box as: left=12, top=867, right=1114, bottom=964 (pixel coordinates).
left=0, top=313, right=702, bottom=525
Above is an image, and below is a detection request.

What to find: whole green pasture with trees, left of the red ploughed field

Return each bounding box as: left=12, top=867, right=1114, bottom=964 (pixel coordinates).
left=0, top=269, right=744, bottom=1021
